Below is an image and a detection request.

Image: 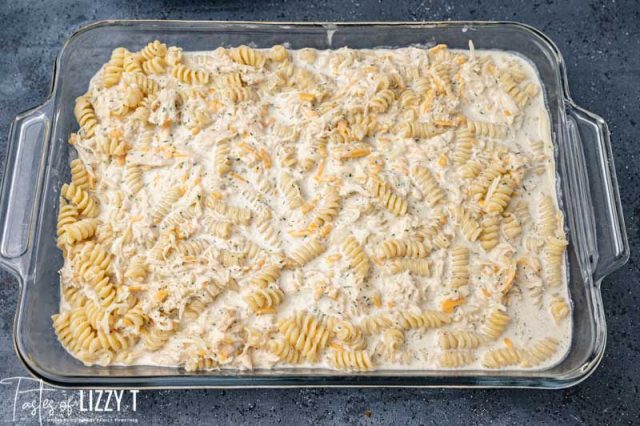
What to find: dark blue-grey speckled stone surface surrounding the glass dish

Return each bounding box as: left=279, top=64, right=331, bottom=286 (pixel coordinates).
left=0, top=0, right=640, bottom=424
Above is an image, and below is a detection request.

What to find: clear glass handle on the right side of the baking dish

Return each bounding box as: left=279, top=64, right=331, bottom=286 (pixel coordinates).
left=567, top=103, right=629, bottom=283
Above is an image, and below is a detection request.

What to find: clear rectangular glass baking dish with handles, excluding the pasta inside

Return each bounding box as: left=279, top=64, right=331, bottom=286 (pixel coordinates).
left=0, top=21, right=629, bottom=388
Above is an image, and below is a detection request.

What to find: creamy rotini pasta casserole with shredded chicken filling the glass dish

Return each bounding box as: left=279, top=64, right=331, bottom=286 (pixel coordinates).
left=53, top=41, right=571, bottom=371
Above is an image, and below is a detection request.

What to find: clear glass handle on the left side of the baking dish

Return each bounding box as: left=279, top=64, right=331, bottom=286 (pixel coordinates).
left=0, top=100, right=53, bottom=275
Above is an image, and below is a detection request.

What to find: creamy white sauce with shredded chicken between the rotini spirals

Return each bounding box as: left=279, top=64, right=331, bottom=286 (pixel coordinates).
left=61, top=42, right=571, bottom=370
